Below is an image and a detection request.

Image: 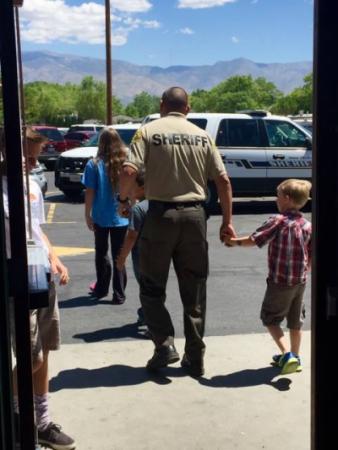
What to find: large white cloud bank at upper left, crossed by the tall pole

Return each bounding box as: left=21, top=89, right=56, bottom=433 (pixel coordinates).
left=20, top=0, right=160, bottom=46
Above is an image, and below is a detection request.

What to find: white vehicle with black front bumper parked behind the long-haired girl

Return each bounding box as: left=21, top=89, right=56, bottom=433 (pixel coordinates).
left=55, top=123, right=141, bottom=199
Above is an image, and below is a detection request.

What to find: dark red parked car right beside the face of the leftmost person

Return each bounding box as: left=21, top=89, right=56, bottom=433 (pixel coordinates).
left=32, top=125, right=67, bottom=170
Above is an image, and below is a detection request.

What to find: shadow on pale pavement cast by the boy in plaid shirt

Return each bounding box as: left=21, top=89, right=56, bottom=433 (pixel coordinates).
left=198, top=367, right=292, bottom=391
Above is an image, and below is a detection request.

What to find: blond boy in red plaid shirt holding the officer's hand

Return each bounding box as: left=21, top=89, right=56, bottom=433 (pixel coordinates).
left=224, top=179, right=311, bottom=374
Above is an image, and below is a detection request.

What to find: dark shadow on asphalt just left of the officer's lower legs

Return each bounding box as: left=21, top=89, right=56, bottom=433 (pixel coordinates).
left=73, top=322, right=149, bottom=343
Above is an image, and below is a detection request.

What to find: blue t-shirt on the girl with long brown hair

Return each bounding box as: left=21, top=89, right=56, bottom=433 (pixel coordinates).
left=82, top=159, right=128, bottom=227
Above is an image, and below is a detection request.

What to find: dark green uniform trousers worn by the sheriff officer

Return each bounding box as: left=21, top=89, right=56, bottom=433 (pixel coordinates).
left=139, top=201, right=208, bottom=361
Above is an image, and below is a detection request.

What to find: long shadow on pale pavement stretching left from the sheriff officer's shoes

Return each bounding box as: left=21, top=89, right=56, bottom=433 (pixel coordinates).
left=49, top=364, right=185, bottom=392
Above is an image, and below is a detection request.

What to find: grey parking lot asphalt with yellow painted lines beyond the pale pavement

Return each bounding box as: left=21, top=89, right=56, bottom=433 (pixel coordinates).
left=44, top=172, right=310, bottom=343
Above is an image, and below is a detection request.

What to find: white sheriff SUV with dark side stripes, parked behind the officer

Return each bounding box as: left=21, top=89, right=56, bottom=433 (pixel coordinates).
left=143, top=111, right=312, bottom=208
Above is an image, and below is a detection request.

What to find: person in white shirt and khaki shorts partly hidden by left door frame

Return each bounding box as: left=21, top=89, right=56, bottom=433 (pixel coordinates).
left=0, top=127, right=76, bottom=450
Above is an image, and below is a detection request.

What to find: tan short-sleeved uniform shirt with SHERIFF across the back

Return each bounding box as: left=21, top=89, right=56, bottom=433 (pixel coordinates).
left=125, top=113, right=226, bottom=202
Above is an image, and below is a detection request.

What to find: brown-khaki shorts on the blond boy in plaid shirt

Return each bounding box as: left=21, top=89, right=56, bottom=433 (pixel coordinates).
left=260, top=279, right=305, bottom=330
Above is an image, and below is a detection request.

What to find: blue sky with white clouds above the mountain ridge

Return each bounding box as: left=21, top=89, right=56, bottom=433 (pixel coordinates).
left=20, top=0, right=313, bottom=67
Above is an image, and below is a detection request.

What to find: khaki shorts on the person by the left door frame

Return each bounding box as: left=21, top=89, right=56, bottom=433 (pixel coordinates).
left=13, top=282, right=61, bottom=363
